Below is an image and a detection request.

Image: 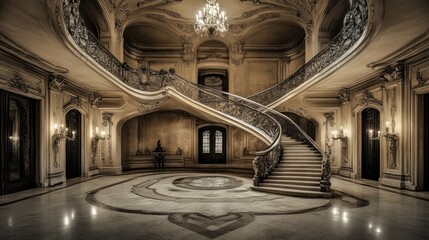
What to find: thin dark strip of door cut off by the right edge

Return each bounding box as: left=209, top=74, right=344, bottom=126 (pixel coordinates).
left=422, top=94, right=429, bottom=191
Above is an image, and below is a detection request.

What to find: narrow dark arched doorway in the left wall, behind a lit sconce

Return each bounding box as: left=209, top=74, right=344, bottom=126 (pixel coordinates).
left=66, top=109, right=82, bottom=179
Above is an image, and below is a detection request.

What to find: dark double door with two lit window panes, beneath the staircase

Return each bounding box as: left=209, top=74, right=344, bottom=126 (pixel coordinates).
left=198, top=126, right=226, bottom=163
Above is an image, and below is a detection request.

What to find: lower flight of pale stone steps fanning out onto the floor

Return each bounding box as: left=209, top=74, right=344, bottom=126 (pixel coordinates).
left=252, top=134, right=333, bottom=197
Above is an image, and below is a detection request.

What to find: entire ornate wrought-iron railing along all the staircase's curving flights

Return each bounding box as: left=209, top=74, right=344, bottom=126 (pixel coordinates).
left=62, top=0, right=371, bottom=190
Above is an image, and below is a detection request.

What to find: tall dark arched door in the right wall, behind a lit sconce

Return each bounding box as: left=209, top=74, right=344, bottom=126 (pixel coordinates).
left=362, top=108, right=380, bottom=181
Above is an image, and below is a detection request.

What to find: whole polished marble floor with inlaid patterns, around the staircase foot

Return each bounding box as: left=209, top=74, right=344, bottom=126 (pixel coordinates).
left=0, top=172, right=429, bottom=239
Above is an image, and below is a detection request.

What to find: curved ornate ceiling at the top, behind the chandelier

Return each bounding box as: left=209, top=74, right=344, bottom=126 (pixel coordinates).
left=109, top=0, right=320, bottom=50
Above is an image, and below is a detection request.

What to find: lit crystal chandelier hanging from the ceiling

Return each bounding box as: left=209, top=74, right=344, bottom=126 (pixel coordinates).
left=194, top=0, right=228, bottom=37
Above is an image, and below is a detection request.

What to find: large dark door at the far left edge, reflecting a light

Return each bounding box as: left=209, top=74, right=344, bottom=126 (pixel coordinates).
left=0, top=91, right=39, bottom=194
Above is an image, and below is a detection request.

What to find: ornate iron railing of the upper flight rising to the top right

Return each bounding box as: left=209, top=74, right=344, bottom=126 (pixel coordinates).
left=248, top=0, right=372, bottom=105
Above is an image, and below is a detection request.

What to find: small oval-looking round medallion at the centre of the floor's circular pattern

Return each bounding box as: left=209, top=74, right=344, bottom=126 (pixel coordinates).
left=173, top=176, right=243, bottom=190
